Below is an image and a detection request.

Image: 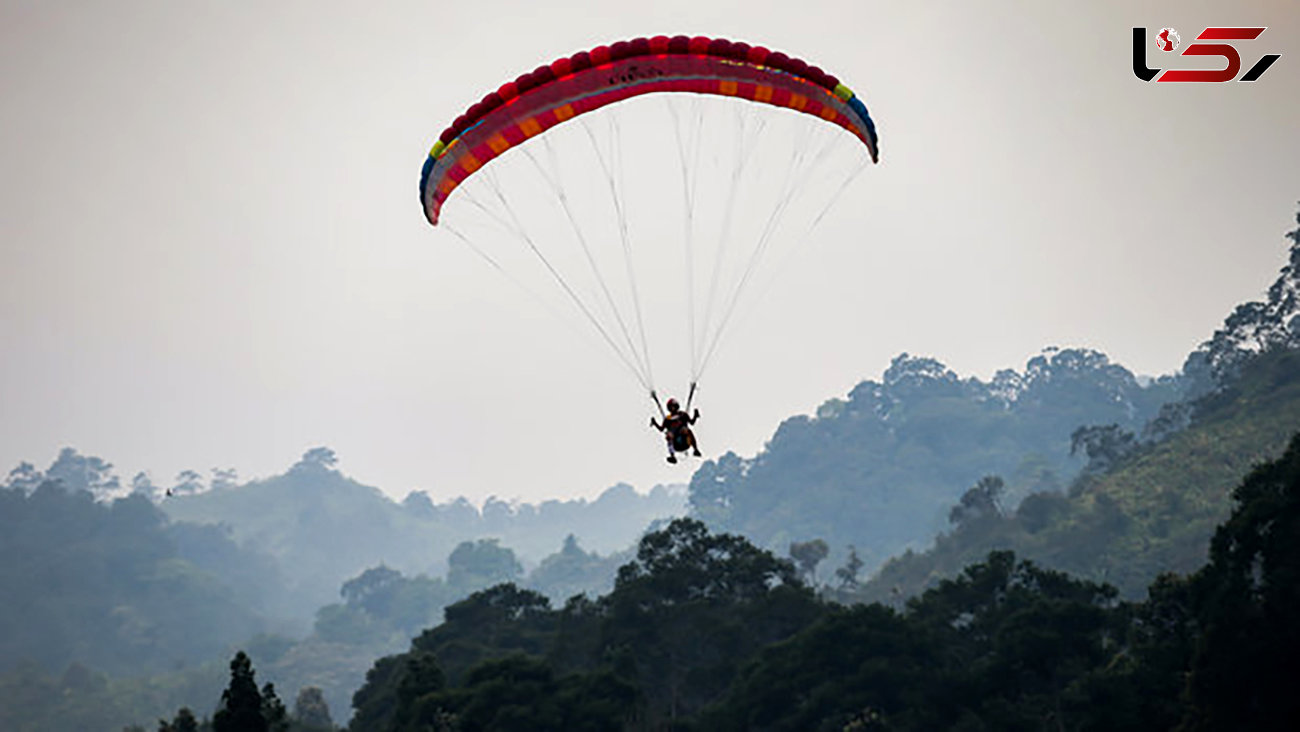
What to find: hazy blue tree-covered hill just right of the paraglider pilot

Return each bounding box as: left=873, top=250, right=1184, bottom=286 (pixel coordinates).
left=690, top=348, right=1187, bottom=571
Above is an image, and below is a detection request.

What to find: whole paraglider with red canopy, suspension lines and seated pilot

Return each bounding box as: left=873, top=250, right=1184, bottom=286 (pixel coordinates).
left=420, top=35, right=879, bottom=463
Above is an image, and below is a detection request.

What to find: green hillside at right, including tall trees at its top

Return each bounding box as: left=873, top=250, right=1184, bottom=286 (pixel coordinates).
left=854, top=209, right=1300, bottom=601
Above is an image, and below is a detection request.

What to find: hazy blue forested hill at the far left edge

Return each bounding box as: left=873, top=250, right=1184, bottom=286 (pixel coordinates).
left=0, top=480, right=263, bottom=673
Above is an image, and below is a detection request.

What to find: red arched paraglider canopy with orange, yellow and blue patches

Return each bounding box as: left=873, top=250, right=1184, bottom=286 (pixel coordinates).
left=420, top=35, right=878, bottom=225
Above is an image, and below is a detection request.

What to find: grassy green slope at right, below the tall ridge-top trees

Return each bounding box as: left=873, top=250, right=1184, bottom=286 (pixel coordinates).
left=855, top=351, right=1300, bottom=602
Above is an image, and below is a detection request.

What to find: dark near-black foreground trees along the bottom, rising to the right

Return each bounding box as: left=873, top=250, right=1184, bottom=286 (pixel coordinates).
left=106, top=434, right=1300, bottom=732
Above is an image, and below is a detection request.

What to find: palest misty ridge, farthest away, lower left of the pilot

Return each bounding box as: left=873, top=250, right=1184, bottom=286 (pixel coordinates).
left=161, top=449, right=685, bottom=619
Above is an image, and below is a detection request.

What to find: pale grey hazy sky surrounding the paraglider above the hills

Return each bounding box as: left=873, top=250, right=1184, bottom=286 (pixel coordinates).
left=0, top=0, right=1300, bottom=501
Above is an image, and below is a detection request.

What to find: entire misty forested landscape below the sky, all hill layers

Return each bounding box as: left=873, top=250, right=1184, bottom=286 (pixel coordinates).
left=0, top=205, right=1300, bottom=732
